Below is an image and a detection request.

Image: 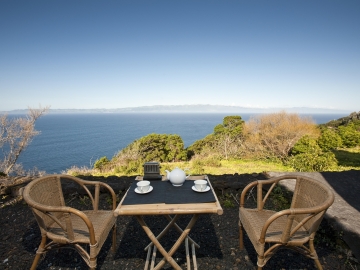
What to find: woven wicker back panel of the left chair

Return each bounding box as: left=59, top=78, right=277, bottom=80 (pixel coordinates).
left=23, top=176, right=65, bottom=231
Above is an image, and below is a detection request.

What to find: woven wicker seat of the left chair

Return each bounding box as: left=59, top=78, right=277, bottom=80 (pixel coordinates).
left=47, top=210, right=116, bottom=250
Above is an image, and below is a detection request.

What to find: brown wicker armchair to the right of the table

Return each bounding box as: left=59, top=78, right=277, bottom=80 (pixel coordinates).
left=239, top=175, right=334, bottom=269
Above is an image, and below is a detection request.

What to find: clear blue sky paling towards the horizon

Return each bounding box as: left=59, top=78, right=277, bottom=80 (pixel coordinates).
left=0, top=0, right=360, bottom=111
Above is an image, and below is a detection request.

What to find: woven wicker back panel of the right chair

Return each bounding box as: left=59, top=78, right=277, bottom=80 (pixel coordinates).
left=291, top=176, right=334, bottom=234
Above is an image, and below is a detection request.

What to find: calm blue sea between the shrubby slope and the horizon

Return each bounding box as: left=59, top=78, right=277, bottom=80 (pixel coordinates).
left=11, top=113, right=346, bottom=173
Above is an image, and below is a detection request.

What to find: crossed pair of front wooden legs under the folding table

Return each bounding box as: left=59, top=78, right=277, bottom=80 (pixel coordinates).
left=136, top=216, right=184, bottom=270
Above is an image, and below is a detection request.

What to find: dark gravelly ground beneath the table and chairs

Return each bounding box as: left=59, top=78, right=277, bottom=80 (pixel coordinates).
left=0, top=174, right=360, bottom=270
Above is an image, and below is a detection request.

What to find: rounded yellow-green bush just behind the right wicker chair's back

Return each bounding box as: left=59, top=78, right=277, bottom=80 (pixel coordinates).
left=287, top=136, right=337, bottom=172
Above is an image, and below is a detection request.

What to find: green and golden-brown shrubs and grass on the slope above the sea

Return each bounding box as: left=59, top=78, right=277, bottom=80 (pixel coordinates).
left=69, top=112, right=360, bottom=175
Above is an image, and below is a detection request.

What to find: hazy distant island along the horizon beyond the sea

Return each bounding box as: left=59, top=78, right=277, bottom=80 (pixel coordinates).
left=0, top=104, right=352, bottom=114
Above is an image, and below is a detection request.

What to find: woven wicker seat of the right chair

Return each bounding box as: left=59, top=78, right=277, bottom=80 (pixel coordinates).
left=239, top=208, right=309, bottom=253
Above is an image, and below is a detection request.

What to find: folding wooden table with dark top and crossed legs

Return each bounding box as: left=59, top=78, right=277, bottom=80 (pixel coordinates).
left=114, top=175, right=223, bottom=269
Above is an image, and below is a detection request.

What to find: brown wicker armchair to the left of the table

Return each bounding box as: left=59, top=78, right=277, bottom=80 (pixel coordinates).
left=23, top=175, right=116, bottom=269
